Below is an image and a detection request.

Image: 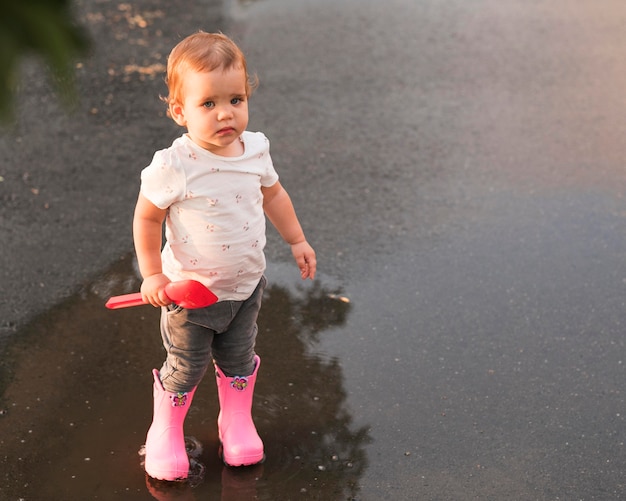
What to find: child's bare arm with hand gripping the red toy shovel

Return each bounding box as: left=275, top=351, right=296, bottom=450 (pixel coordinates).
left=133, top=194, right=171, bottom=306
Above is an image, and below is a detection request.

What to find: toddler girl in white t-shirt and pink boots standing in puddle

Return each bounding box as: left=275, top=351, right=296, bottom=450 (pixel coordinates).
left=133, top=32, right=316, bottom=480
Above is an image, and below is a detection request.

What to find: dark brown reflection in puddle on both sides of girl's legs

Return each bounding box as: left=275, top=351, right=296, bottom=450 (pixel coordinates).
left=0, top=257, right=369, bottom=501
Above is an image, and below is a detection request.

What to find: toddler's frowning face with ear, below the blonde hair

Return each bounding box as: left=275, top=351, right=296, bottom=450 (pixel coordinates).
left=170, top=68, right=248, bottom=156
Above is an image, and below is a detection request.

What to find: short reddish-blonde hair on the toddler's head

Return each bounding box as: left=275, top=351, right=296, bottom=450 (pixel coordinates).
left=161, top=31, right=258, bottom=115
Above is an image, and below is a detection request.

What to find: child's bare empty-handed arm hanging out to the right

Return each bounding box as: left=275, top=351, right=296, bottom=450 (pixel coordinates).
left=261, top=182, right=317, bottom=280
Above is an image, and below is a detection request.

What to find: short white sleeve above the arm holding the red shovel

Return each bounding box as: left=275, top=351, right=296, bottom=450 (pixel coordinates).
left=141, top=150, right=186, bottom=209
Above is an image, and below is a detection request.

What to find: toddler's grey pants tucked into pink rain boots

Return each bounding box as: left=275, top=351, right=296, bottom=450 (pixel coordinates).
left=160, top=277, right=267, bottom=392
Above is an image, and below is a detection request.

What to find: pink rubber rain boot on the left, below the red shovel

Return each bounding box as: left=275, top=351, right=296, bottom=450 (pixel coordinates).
left=145, top=369, right=196, bottom=481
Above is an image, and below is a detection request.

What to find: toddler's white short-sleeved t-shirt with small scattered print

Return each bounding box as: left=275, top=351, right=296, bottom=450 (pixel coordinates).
left=141, top=132, right=278, bottom=301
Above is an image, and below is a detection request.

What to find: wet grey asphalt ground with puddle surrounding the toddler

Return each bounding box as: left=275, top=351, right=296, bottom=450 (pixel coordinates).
left=0, top=0, right=626, bottom=501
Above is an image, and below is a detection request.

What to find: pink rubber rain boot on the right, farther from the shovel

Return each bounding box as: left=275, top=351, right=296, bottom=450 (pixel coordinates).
left=215, top=355, right=264, bottom=466
